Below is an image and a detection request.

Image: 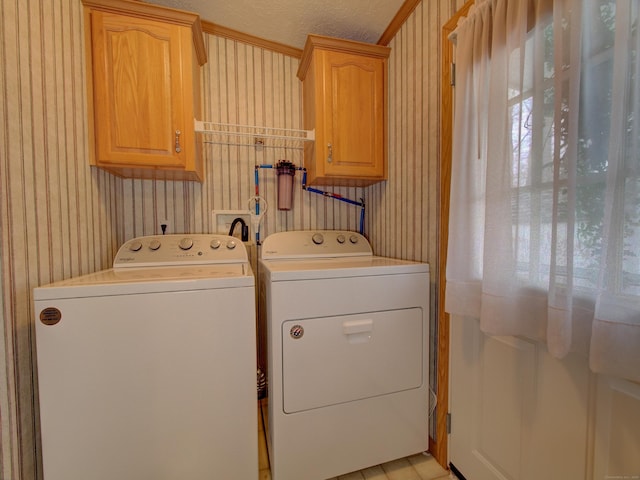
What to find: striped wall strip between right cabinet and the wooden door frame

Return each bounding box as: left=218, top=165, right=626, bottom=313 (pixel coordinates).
left=365, top=0, right=465, bottom=450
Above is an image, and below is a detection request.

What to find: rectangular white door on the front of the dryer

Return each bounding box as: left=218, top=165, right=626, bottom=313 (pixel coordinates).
left=282, top=308, right=424, bottom=413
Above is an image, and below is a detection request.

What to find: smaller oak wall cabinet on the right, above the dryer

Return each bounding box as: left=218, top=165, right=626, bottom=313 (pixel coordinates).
left=298, top=35, right=390, bottom=187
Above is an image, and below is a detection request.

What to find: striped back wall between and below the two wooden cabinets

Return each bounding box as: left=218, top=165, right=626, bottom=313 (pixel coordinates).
left=119, top=34, right=362, bottom=241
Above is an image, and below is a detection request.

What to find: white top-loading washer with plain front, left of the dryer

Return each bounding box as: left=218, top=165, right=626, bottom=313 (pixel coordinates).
left=34, top=235, right=258, bottom=480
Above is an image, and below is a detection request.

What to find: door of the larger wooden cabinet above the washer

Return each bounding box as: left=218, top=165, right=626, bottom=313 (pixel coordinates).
left=91, top=11, right=193, bottom=168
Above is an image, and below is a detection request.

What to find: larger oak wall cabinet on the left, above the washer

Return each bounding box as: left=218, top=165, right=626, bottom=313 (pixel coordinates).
left=82, top=0, right=207, bottom=182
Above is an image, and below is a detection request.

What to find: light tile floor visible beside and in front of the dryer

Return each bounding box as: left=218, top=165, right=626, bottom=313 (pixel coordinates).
left=258, top=400, right=454, bottom=480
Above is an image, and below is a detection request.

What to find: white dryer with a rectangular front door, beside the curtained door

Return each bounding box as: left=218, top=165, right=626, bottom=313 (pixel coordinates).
left=259, top=230, right=429, bottom=480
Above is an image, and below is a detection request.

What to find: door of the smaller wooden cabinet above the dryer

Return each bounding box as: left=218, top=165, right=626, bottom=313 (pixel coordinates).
left=318, top=52, right=385, bottom=180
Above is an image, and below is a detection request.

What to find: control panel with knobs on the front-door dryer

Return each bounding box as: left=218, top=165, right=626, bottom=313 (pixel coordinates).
left=262, top=230, right=373, bottom=260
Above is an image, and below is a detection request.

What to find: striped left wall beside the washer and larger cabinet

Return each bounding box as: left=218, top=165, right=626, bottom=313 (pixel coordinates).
left=0, top=0, right=120, bottom=480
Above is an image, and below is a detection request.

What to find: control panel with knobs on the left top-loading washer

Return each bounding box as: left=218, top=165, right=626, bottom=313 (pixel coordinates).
left=113, top=234, right=249, bottom=268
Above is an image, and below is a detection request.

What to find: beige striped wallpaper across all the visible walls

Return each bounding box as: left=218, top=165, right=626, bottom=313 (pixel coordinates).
left=0, top=0, right=463, bottom=480
